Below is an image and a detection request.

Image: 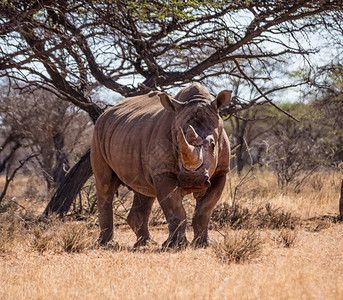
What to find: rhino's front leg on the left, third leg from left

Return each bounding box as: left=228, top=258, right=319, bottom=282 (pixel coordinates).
left=154, top=173, right=188, bottom=249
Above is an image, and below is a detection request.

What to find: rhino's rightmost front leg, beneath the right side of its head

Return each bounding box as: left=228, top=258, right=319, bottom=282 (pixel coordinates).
left=192, top=174, right=226, bottom=247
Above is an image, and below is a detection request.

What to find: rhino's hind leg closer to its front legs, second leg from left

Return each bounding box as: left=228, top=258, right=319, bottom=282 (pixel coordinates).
left=127, top=192, right=155, bottom=248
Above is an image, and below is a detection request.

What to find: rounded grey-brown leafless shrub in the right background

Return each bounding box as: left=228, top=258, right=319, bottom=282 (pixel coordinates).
left=267, top=103, right=323, bottom=191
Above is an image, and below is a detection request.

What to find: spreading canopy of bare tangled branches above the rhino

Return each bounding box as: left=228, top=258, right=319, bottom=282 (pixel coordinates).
left=0, top=0, right=341, bottom=214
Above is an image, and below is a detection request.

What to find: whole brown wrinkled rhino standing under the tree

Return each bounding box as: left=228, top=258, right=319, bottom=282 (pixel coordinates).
left=91, top=84, right=231, bottom=247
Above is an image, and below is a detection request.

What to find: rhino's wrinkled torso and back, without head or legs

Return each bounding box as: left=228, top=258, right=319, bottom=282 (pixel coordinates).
left=95, top=93, right=177, bottom=196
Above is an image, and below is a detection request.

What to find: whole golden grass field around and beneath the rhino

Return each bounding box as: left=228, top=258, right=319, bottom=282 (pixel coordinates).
left=0, top=172, right=343, bottom=299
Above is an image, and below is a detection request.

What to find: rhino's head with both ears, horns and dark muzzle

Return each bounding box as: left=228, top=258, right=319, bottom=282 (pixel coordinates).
left=158, top=90, right=231, bottom=192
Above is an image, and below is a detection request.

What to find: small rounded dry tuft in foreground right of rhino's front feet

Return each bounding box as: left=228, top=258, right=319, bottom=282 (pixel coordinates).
left=214, top=230, right=263, bottom=263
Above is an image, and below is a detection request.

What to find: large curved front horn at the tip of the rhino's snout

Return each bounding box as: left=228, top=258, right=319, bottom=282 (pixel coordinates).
left=179, top=128, right=203, bottom=170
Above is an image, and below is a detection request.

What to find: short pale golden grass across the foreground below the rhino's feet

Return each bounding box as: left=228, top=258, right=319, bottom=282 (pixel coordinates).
left=0, top=225, right=343, bottom=299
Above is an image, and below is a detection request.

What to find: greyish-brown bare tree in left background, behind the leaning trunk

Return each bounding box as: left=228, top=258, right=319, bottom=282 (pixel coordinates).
left=0, top=90, right=90, bottom=189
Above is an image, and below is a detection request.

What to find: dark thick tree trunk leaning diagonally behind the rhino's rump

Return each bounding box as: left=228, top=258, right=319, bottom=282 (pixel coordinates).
left=43, top=150, right=92, bottom=217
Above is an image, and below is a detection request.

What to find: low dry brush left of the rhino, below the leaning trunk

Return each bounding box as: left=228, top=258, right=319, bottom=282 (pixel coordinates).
left=0, top=200, right=96, bottom=254
